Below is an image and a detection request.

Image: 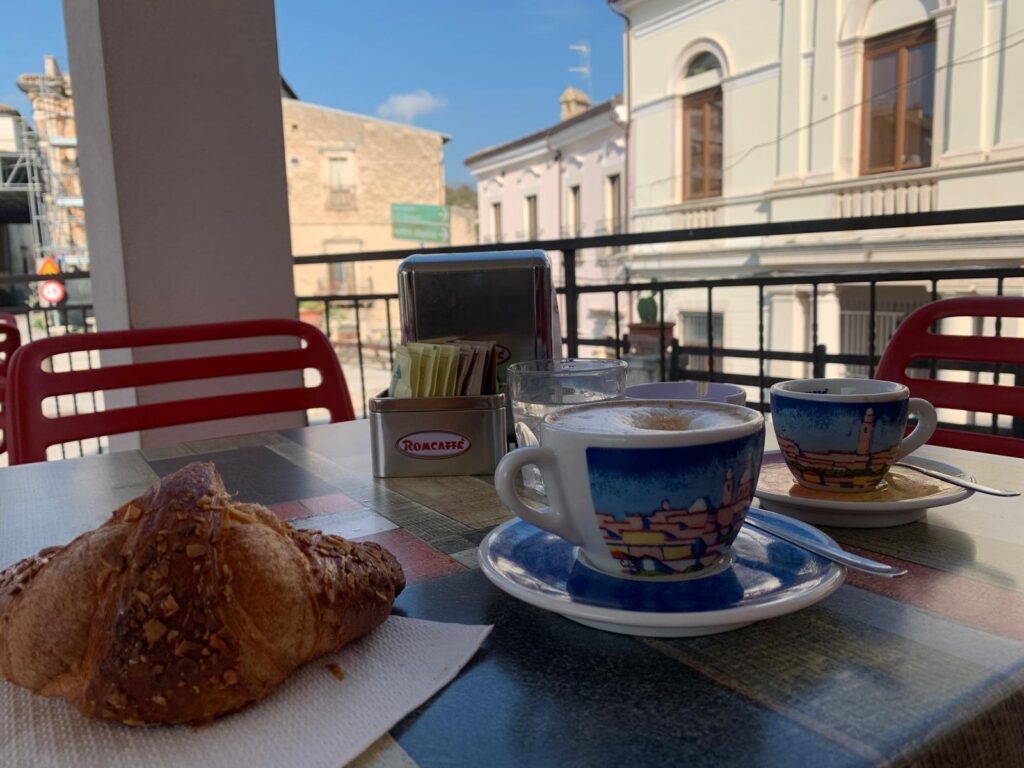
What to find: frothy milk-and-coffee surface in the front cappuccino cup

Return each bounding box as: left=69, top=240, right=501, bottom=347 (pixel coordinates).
left=548, top=402, right=756, bottom=435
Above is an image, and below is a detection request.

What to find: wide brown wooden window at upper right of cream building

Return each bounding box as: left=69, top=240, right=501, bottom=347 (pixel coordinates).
left=861, top=23, right=935, bottom=174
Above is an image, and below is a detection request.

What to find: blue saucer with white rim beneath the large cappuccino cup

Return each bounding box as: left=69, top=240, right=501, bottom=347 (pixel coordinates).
left=479, top=512, right=846, bottom=637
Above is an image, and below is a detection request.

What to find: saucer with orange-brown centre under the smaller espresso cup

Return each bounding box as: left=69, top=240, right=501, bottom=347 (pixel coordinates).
left=754, top=451, right=974, bottom=528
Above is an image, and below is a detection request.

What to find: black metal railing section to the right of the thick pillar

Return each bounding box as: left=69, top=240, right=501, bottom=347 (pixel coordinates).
left=295, top=206, right=1024, bottom=417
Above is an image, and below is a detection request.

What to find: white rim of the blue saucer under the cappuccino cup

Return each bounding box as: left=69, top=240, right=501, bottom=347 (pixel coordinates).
left=477, top=513, right=847, bottom=634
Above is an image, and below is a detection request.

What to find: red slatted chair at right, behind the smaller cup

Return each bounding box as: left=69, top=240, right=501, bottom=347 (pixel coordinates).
left=874, top=296, right=1024, bottom=458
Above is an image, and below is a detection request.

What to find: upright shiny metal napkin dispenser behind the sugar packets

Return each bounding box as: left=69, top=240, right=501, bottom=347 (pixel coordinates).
left=398, top=251, right=561, bottom=372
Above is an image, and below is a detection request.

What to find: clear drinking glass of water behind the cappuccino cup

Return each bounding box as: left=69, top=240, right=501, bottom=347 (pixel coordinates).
left=506, top=357, right=627, bottom=494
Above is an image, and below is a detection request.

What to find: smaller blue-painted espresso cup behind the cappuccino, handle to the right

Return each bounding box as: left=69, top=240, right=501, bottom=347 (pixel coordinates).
left=771, top=379, right=938, bottom=493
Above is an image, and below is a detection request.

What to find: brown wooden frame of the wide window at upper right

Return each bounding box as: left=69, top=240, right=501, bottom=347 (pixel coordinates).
left=860, top=22, right=935, bottom=176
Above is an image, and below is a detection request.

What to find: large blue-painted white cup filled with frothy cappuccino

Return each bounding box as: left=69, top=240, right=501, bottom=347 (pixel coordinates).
left=495, top=400, right=765, bottom=580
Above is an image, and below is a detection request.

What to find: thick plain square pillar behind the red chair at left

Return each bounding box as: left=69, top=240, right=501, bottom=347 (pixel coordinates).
left=65, top=0, right=300, bottom=447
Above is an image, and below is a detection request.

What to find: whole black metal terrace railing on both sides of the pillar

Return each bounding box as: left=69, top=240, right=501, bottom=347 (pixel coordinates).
left=0, top=206, right=1024, bottom=456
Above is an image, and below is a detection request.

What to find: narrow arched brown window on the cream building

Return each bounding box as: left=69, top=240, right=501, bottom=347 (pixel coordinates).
left=683, top=51, right=722, bottom=200
